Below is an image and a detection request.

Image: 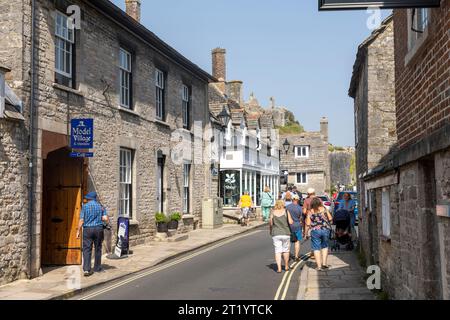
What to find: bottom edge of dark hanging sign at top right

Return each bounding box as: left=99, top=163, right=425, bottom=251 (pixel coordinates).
left=319, top=0, right=441, bottom=10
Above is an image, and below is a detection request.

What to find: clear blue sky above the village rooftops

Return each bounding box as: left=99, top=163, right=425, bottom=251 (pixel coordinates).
left=113, top=0, right=389, bottom=146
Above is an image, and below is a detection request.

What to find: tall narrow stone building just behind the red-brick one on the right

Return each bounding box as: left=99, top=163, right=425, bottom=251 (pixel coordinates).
left=349, top=16, right=397, bottom=274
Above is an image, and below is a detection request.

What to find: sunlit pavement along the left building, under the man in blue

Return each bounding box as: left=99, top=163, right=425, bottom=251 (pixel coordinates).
left=0, top=222, right=264, bottom=300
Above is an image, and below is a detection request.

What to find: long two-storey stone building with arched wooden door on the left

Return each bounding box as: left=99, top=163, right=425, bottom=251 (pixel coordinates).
left=0, top=0, right=214, bottom=283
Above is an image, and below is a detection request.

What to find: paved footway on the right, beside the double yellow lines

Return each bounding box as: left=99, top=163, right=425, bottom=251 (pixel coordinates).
left=297, top=251, right=376, bottom=300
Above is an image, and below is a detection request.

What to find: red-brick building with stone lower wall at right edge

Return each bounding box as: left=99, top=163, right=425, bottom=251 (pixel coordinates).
left=350, top=0, right=450, bottom=299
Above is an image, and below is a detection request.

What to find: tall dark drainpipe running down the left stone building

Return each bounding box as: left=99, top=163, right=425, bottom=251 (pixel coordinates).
left=28, top=0, right=36, bottom=279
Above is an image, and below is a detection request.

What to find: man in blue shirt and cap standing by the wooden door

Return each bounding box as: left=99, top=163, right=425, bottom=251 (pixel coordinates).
left=77, top=192, right=109, bottom=277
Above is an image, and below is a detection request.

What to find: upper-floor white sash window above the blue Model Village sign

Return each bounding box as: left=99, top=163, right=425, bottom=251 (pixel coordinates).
left=55, top=11, right=75, bottom=79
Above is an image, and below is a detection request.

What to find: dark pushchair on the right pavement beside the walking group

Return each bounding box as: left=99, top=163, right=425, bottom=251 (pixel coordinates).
left=331, top=210, right=354, bottom=251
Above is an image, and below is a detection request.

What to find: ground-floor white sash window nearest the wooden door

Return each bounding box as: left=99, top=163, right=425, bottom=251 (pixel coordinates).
left=119, top=148, right=134, bottom=219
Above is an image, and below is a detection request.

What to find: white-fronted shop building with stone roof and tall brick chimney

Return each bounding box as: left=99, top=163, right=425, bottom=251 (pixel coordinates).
left=209, top=48, right=279, bottom=215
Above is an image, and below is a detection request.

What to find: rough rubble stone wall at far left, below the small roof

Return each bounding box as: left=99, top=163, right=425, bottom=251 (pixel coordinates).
left=0, top=119, right=28, bottom=285
